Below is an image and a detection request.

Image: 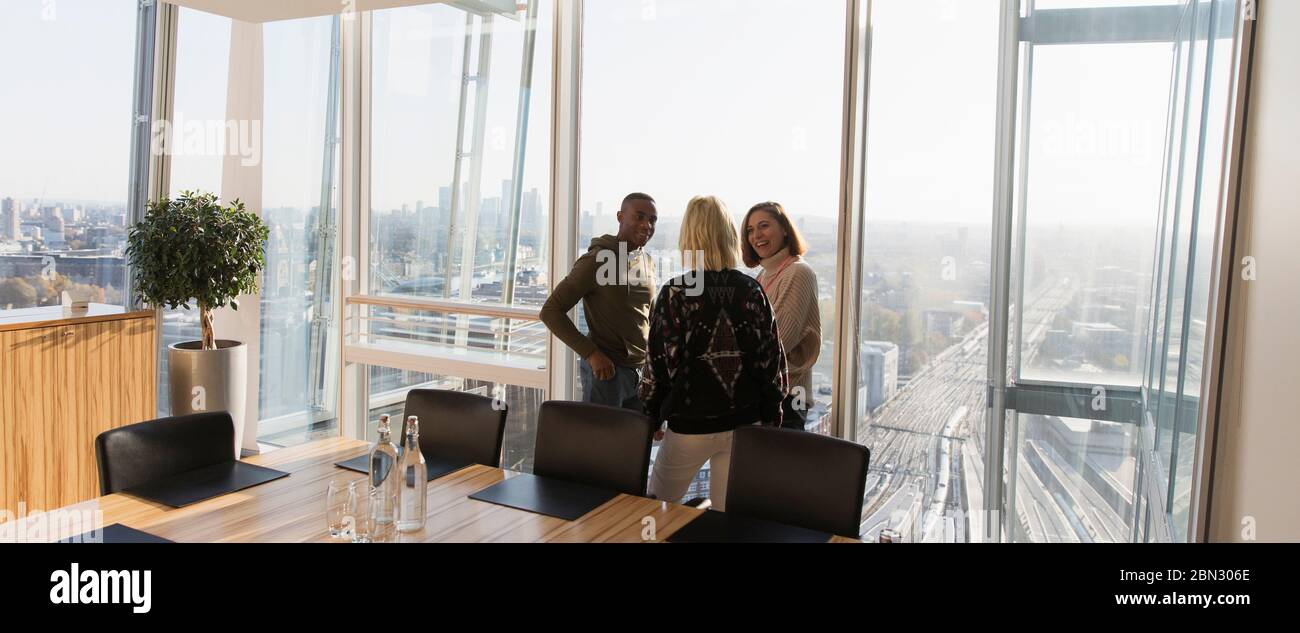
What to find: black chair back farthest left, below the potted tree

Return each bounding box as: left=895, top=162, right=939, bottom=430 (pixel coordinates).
left=95, top=411, right=235, bottom=494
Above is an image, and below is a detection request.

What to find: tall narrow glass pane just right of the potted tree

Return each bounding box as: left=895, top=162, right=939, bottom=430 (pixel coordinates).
left=257, top=16, right=339, bottom=446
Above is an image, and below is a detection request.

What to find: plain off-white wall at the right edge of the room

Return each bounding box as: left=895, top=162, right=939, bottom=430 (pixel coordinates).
left=1209, top=0, right=1300, bottom=542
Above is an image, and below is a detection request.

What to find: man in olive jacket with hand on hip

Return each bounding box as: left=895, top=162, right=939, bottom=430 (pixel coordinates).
left=542, top=194, right=659, bottom=412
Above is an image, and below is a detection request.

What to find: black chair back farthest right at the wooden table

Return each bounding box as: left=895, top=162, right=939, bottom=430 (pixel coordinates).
left=727, top=426, right=871, bottom=538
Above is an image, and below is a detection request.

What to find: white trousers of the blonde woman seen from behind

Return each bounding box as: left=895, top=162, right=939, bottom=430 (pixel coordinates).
left=650, top=430, right=732, bottom=511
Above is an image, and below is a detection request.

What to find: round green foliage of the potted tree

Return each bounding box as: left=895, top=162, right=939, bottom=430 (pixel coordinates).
left=126, top=191, right=270, bottom=339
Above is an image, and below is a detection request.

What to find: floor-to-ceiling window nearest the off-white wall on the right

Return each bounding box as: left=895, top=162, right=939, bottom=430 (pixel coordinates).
left=1002, top=0, right=1235, bottom=542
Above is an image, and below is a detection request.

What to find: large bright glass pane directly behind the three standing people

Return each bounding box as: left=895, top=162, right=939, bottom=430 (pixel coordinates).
left=573, top=0, right=846, bottom=432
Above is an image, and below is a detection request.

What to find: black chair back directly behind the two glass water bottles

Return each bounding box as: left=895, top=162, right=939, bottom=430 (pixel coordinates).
left=398, top=389, right=507, bottom=468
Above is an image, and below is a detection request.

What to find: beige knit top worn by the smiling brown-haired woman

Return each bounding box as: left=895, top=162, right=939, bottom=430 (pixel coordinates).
left=758, top=250, right=822, bottom=407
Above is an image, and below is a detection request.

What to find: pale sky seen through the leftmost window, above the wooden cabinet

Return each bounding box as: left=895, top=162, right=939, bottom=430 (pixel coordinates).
left=0, top=0, right=137, bottom=203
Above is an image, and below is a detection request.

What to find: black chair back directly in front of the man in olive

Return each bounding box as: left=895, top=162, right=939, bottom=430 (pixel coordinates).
left=533, top=402, right=657, bottom=497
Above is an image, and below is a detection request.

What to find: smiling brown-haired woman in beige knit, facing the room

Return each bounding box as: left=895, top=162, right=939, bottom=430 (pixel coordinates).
left=742, top=203, right=822, bottom=430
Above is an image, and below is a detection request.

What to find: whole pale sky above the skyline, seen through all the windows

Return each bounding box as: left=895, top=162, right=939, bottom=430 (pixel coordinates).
left=0, top=0, right=1173, bottom=224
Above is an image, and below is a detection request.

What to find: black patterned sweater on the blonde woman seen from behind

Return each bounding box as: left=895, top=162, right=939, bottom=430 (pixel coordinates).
left=640, top=270, right=788, bottom=434
